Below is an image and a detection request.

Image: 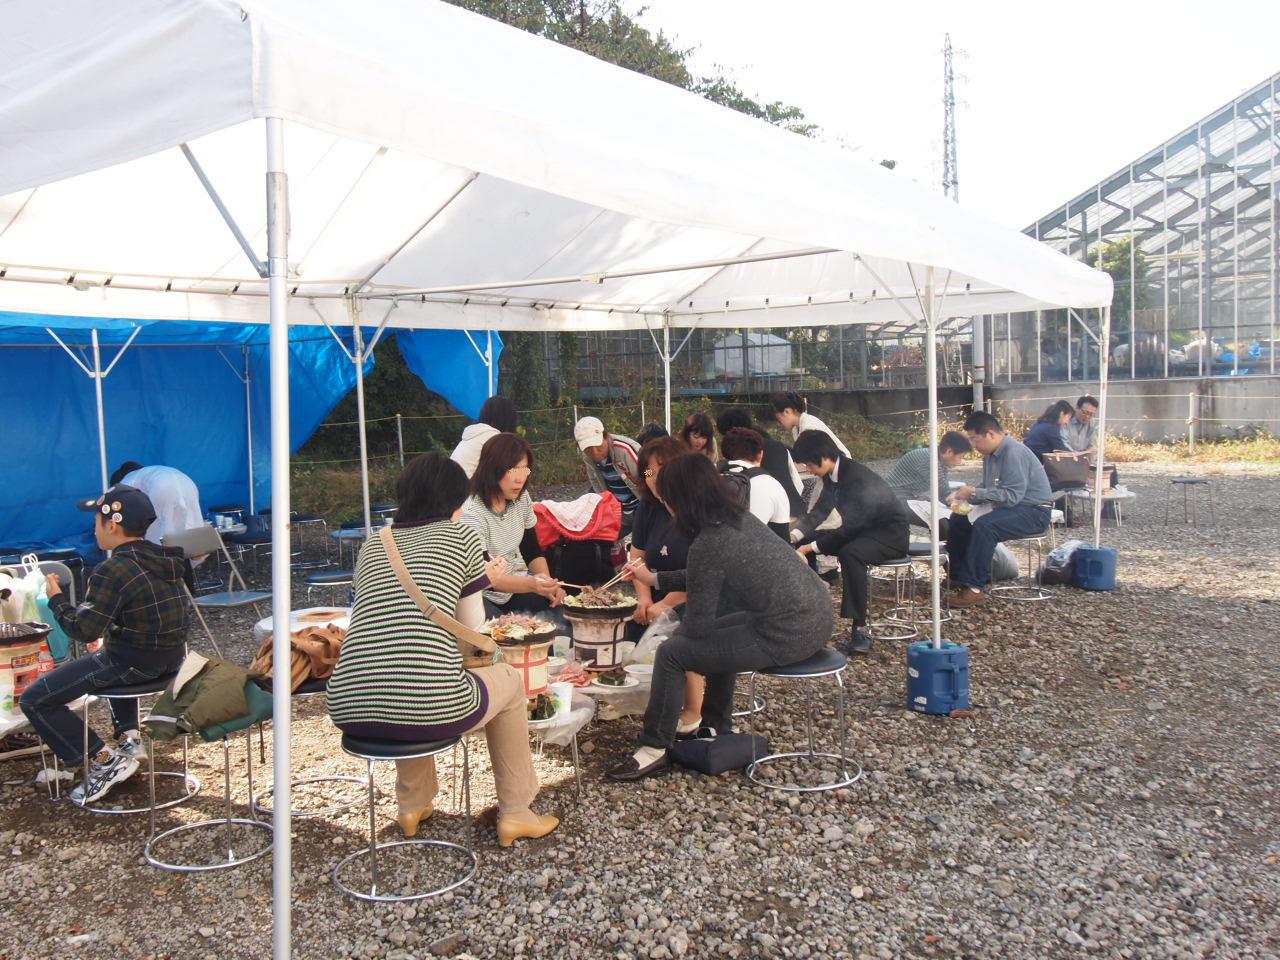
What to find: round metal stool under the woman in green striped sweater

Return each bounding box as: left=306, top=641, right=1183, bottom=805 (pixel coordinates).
left=333, top=733, right=480, bottom=904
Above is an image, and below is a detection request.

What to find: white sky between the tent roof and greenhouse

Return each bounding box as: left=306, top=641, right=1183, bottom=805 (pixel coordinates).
left=640, top=0, right=1280, bottom=229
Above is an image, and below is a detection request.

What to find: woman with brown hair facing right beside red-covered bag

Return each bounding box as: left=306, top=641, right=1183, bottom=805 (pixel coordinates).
left=462, top=434, right=564, bottom=616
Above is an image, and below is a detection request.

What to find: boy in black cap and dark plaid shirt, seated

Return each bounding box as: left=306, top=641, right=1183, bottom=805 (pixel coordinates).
left=20, top=484, right=191, bottom=803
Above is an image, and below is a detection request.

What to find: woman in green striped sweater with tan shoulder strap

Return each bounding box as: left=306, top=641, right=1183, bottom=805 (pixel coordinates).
left=328, top=453, right=559, bottom=846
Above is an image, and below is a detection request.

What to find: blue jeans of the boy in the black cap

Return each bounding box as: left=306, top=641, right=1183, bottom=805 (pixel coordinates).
left=20, top=650, right=173, bottom=767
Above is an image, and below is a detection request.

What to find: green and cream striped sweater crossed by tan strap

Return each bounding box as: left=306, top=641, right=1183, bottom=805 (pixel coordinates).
left=328, top=520, right=488, bottom=727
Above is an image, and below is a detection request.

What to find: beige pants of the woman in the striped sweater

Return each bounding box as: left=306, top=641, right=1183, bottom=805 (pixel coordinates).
left=396, top=663, right=538, bottom=817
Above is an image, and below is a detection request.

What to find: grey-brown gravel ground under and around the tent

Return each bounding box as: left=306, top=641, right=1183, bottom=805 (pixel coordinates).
left=0, top=465, right=1280, bottom=960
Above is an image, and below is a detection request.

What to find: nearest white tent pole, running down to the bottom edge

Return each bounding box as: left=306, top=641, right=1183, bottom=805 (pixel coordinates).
left=266, top=116, right=293, bottom=960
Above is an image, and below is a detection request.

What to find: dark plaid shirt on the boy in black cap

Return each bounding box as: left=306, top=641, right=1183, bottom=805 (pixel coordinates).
left=49, top=540, right=191, bottom=664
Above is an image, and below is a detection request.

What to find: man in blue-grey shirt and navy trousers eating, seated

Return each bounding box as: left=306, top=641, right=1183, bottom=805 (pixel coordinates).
left=947, top=411, right=1053, bottom=607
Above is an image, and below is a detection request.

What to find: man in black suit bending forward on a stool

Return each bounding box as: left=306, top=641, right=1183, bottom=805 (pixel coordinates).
left=791, top=430, right=910, bottom=653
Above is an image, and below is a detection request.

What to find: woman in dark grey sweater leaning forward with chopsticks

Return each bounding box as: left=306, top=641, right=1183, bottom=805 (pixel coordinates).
left=607, top=453, right=835, bottom=780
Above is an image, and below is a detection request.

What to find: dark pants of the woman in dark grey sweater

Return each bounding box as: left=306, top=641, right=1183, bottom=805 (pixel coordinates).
left=640, top=613, right=780, bottom=749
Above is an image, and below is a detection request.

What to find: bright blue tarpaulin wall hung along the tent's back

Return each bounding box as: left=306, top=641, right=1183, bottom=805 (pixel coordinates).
left=0, top=311, right=499, bottom=552
